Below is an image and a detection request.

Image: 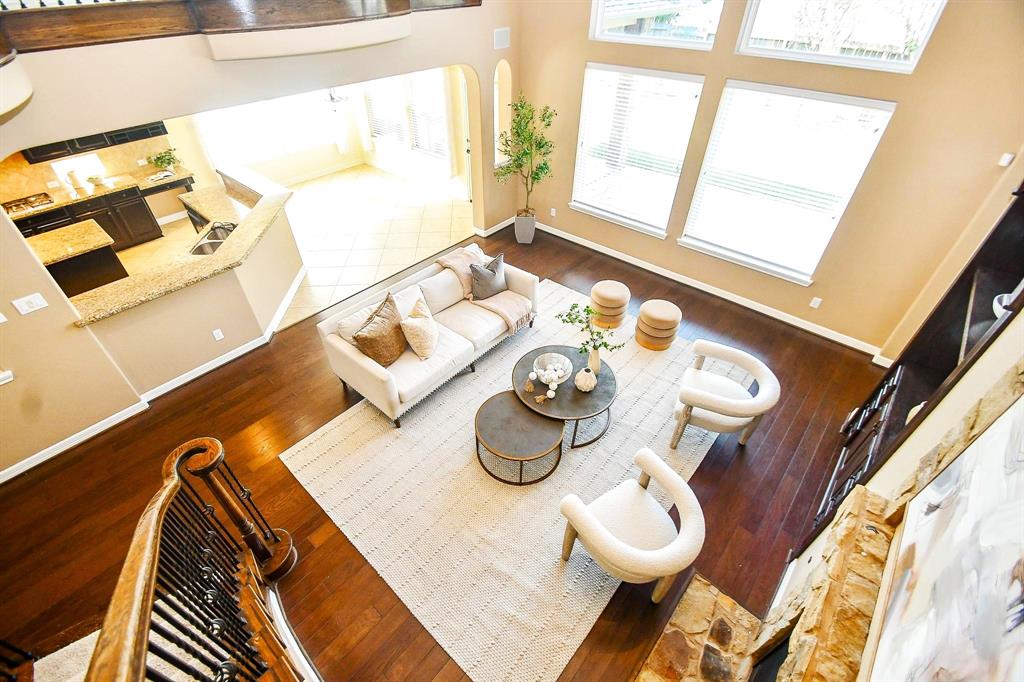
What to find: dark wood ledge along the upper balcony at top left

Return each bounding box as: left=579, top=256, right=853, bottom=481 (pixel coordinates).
left=0, top=0, right=481, bottom=53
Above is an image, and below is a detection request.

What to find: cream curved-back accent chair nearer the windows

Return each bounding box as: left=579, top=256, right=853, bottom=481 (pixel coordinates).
left=672, top=339, right=781, bottom=449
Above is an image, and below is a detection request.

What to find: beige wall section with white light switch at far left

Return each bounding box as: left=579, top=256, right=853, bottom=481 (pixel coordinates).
left=0, top=215, right=139, bottom=471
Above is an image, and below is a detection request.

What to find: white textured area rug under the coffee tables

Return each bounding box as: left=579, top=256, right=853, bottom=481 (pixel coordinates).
left=281, top=281, right=750, bottom=681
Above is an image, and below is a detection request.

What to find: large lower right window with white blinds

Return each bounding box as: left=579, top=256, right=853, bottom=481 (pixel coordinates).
left=679, top=81, right=896, bottom=285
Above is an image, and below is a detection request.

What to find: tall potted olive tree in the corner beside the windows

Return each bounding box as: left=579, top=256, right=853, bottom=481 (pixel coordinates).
left=495, top=94, right=557, bottom=244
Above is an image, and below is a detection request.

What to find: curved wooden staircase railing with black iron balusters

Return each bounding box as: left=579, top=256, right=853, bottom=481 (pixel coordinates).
left=86, top=438, right=315, bottom=682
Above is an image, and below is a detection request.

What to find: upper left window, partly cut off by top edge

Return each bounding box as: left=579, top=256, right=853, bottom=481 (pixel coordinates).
left=590, top=0, right=724, bottom=50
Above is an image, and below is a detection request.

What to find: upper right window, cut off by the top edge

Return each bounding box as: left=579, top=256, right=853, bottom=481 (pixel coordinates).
left=739, top=0, right=945, bottom=74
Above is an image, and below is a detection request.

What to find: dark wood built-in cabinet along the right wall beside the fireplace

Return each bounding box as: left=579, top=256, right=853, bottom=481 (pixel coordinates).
left=796, top=186, right=1024, bottom=554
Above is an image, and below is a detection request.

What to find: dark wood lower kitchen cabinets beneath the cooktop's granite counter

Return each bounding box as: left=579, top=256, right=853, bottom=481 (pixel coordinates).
left=14, top=187, right=163, bottom=251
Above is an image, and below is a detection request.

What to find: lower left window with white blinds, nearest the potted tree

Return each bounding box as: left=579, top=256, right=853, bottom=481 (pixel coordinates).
left=569, top=63, right=703, bottom=237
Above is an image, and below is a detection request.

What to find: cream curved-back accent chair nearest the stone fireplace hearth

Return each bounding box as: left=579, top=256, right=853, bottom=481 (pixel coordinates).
left=561, top=447, right=705, bottom=604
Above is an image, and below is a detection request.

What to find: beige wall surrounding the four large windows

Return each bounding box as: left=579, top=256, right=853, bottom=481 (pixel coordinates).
left=513, top=0, right=1024, bottom=346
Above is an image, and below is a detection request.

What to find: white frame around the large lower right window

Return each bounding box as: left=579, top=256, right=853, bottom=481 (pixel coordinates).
left=676, top=79, right=896, bottom=287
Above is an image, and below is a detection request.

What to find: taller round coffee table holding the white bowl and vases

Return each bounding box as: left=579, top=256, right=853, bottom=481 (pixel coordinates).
left=512, top=346, right=618, bottom=447
